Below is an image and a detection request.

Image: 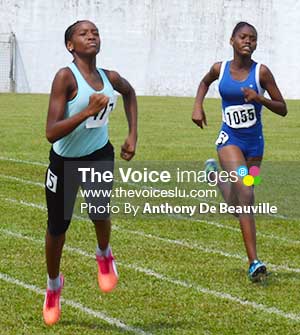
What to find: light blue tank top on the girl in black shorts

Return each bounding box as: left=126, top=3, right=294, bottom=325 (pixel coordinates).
left=53, top=63, right=114, bottom=157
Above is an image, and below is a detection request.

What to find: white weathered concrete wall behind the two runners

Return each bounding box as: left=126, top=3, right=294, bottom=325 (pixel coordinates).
left=0, top=0, right=300, bottom=98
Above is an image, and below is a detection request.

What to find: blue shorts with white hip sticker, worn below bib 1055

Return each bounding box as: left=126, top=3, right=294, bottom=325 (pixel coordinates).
left=216, top=125, right=264, bottom=159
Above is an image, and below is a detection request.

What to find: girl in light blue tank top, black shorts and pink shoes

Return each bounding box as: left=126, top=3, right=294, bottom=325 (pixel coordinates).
left=43, top=21, right=137, bottom=325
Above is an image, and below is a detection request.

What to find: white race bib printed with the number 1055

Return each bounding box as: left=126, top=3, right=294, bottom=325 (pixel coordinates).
left=223, top=104, right=256, bottom=129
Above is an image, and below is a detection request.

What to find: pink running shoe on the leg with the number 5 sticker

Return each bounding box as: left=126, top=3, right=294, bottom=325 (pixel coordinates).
left=43, top=275, right=64, bottom=326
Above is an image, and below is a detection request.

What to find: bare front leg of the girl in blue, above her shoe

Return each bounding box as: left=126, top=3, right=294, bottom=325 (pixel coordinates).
left=218, top=145, right=257, bottom=263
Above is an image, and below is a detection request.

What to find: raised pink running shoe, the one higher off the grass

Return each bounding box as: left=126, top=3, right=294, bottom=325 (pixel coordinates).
left=96, top=249, right=118, bottom=293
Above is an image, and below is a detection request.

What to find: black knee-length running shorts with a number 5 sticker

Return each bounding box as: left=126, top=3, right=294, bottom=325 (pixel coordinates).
left=45, top=142, right=114, bottom=235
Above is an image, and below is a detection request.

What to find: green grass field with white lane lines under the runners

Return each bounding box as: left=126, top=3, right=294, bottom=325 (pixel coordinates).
left=0, top=94, right=300, bottom=335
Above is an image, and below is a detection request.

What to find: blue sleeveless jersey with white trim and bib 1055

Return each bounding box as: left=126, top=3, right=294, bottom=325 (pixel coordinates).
left=219, top=61, right=264, bottom=137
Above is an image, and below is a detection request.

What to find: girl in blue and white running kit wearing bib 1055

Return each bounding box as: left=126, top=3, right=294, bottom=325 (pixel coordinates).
left=192, top=22, right=287, bottom=281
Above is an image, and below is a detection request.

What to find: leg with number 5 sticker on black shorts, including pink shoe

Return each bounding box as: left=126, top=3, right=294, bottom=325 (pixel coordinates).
left=43, top=151, right=78, bottom=325
